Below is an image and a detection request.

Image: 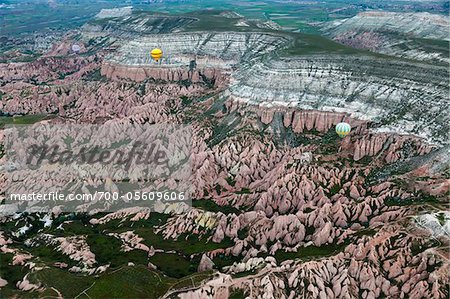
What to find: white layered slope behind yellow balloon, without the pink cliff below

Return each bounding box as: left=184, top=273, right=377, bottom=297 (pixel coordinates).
left=107, top=32, right=289, bottom=68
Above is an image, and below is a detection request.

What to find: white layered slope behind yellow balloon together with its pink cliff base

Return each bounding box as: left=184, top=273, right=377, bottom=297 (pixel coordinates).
left=102, top=32, right=288, bottom=86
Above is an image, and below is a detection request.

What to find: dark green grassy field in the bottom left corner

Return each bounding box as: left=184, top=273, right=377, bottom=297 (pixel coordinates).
left=0, top=262, right=214, bottom=299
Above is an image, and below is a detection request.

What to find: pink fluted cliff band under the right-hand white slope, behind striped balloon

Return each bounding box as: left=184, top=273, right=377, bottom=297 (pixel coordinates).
left=226, top=100, right=435, bottom=163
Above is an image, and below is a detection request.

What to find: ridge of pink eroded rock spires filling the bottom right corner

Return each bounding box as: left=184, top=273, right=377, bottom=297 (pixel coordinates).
left=174, top=224, right=449, bottom=299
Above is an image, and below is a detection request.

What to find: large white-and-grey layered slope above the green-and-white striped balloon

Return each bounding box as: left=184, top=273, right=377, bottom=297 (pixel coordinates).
left=228, top=56, right=449, bottom=143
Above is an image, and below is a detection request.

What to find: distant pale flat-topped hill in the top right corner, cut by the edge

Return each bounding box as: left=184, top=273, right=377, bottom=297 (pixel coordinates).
left=322, top=11, right=450, bottom=63
